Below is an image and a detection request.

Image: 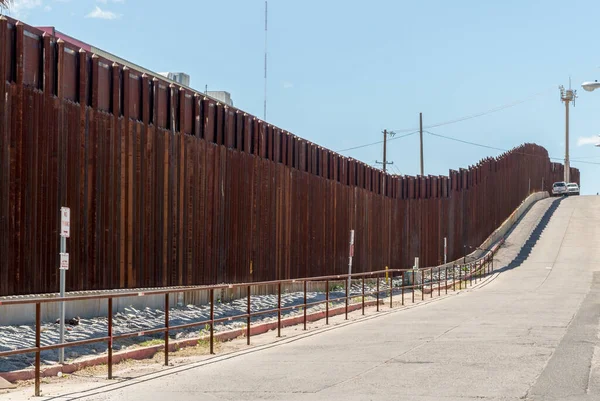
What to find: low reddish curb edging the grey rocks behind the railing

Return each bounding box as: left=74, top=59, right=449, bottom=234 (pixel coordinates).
left=0, top=300, right=384, bottom=383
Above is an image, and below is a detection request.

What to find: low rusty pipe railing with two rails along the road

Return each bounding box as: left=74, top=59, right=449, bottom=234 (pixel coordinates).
left=0, top=248, right=502, bottom=396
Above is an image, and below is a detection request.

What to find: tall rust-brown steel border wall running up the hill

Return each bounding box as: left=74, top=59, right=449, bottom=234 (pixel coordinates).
left=0, top=19, right=579, bottom=295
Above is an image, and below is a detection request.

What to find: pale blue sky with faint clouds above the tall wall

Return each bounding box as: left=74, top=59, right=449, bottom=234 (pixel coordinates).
left=11, top=0, right=600, bottom=194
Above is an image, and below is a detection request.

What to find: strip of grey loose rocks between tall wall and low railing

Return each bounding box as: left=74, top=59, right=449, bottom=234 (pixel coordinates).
left=0, top=279, right=409, bottom=372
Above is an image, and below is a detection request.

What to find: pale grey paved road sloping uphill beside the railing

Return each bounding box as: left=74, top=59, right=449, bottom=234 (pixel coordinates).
left=5, top=196, right=600, bottom=401
